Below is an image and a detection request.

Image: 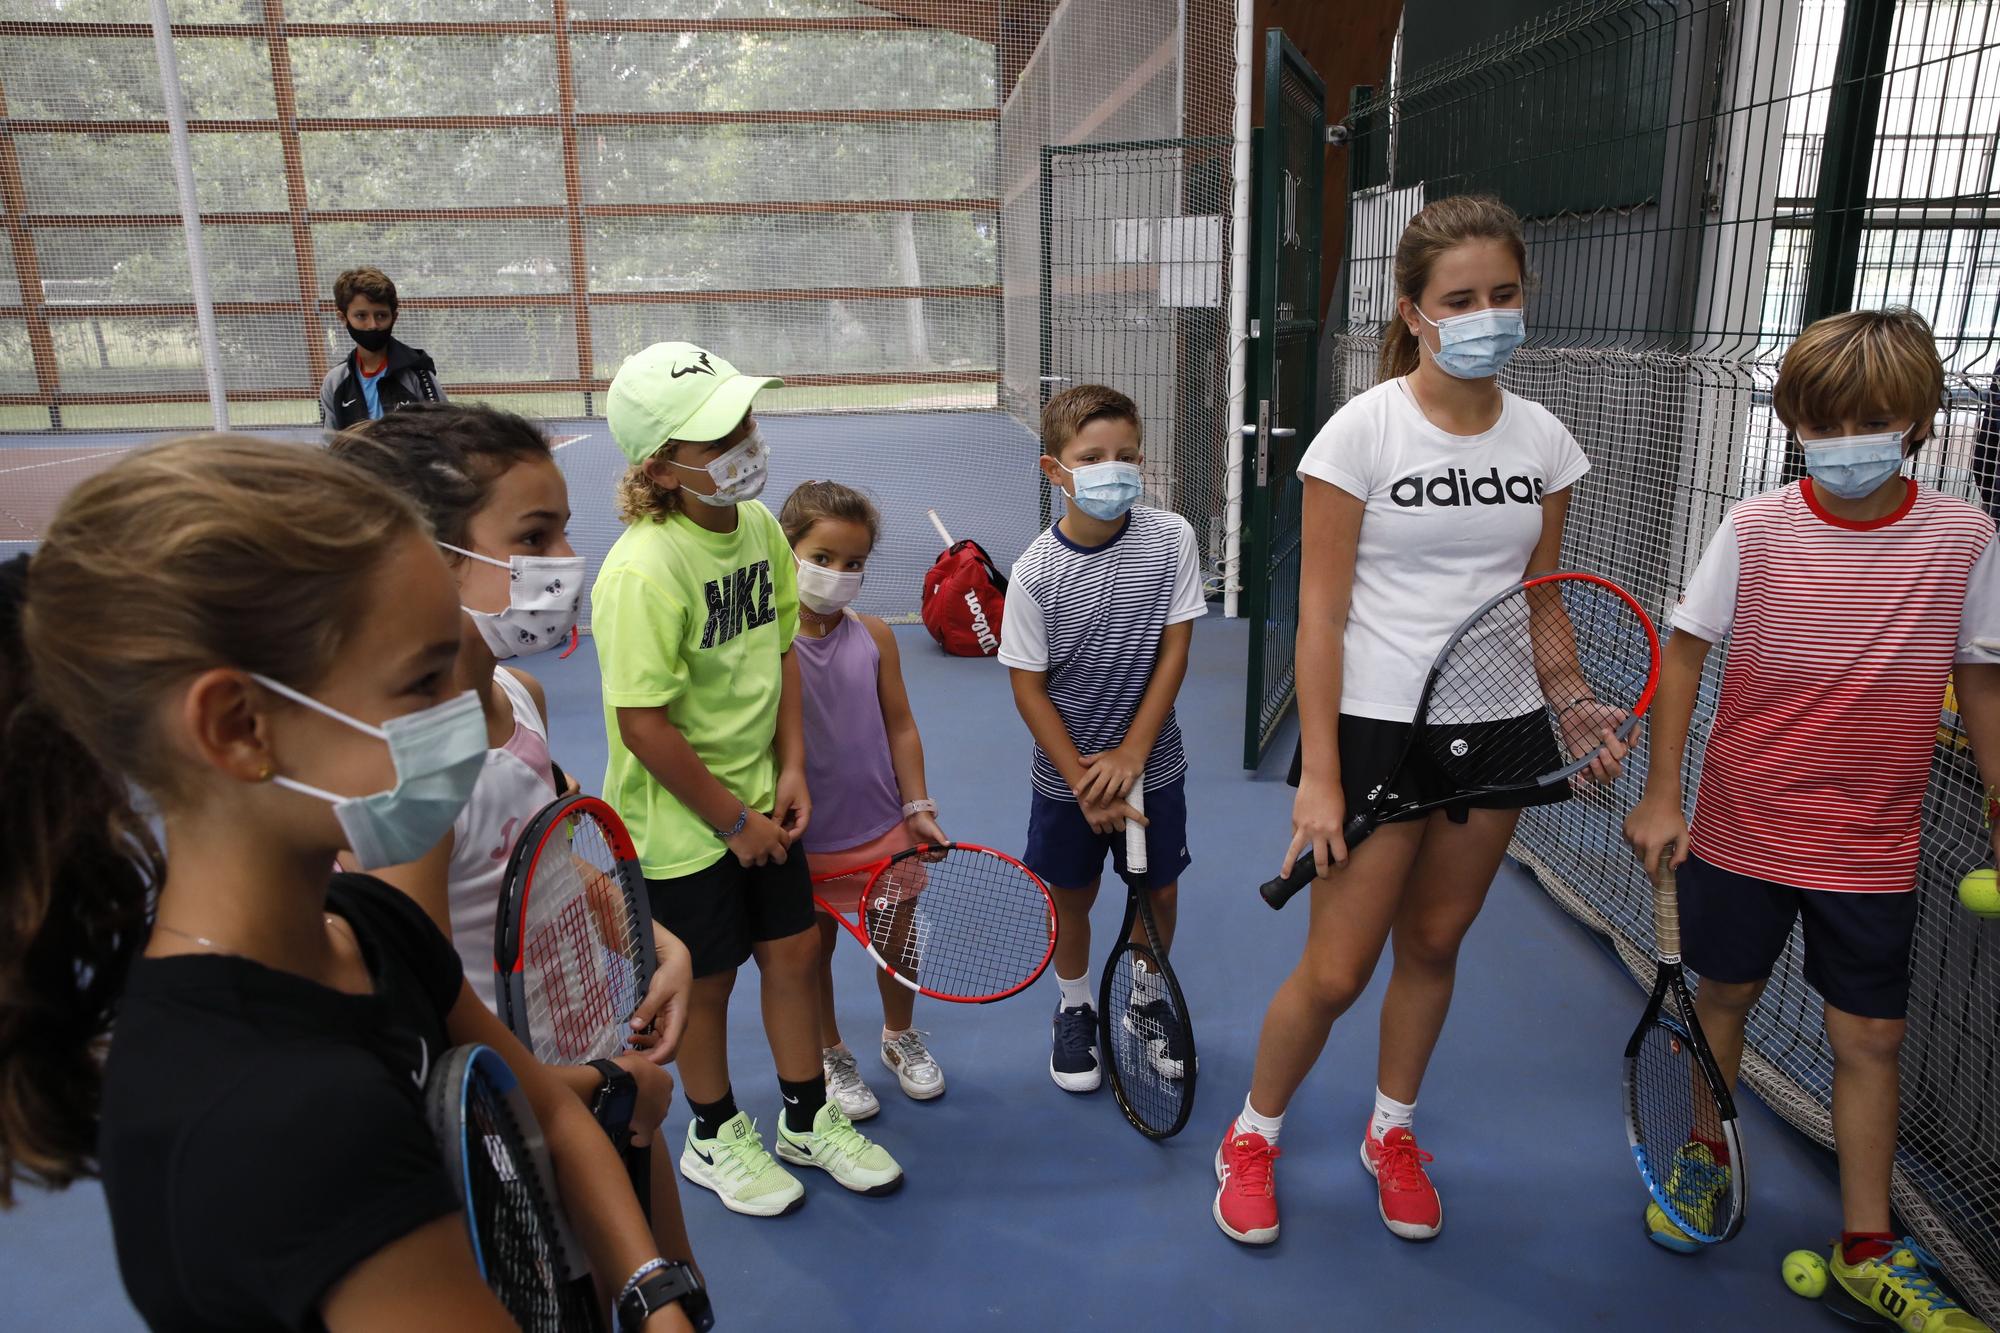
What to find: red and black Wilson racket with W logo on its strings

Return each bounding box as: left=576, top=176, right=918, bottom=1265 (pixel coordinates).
left=494, top=797, right=654, bottom=1211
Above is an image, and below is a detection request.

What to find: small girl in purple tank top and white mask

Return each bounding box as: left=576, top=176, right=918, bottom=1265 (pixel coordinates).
left=778, top=480, right=946, bottom=1121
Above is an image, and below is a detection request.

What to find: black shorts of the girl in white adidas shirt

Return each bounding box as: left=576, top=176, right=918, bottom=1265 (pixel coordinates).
left=1286, top=709, right=1570, bottom=825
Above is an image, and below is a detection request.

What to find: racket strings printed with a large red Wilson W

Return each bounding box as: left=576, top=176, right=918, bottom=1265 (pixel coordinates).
left=522, top=815, right=650, bottom=1065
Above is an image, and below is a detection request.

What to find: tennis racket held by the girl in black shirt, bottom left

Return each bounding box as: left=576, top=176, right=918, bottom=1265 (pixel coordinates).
left=424, top=1045, right=604, bottom=1333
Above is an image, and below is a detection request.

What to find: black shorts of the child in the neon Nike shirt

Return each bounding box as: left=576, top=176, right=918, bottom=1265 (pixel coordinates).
left=646, top=847, right=814, bottom=977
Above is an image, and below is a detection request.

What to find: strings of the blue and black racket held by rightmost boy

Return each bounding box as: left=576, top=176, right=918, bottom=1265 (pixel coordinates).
left=1626, top=1023, right=1740, bottom=1241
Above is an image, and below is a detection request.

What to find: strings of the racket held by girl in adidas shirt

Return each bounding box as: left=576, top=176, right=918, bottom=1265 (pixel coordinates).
left=1422, top=578, right=1654, bottom=791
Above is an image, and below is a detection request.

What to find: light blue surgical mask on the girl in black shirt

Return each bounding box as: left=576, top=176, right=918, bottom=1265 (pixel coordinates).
left=250, top=675, right=486, bottom=871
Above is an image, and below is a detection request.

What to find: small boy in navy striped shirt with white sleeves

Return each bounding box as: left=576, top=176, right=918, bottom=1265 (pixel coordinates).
left=1000, top=384, right=1208, bottom=1093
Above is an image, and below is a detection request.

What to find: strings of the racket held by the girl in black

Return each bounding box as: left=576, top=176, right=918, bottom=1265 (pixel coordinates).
left=466, top=1077, right=596, bottom=1333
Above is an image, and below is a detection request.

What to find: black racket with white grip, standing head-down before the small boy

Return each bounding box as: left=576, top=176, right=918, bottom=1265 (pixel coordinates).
left=1098, top=779, right=1196, bottom=1139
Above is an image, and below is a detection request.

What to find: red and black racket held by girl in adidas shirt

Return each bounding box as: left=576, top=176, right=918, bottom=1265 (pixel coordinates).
left=1260, top=572, right=1660, bottom=907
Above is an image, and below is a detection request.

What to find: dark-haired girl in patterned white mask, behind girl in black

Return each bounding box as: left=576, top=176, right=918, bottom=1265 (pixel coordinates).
left=332, top=404, right=690, bottom=1259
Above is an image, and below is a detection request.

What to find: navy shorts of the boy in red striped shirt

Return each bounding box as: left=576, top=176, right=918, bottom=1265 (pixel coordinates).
left=1678, top=857, right=1918, bottom=1019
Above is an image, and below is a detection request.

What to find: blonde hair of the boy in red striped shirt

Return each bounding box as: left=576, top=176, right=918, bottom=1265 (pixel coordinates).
left=1770, top=308, right=1944, bottom=440
